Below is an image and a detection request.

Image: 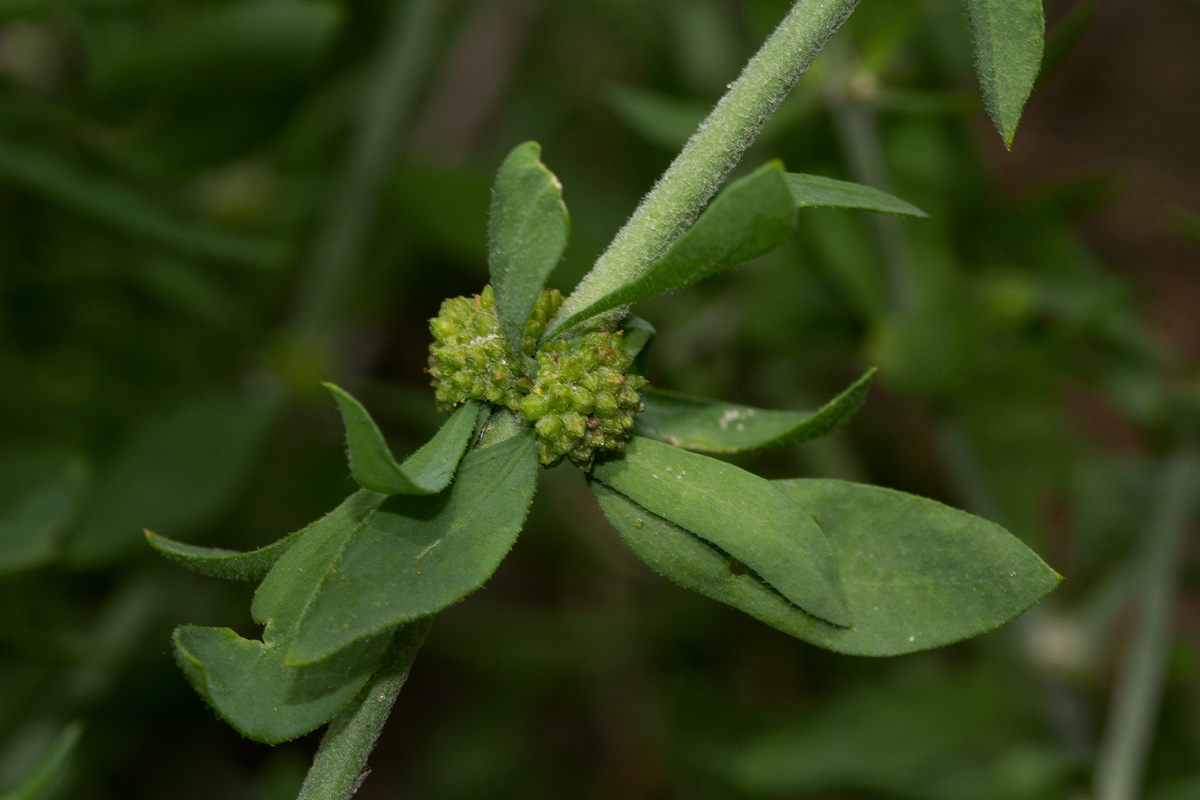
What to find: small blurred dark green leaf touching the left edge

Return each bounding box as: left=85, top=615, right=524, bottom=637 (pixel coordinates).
left=0, top=464, right=84, bottom=575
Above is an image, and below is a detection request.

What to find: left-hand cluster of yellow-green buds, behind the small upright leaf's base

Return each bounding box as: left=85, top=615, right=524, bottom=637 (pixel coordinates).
left=427, top=285, right=563, bottom=411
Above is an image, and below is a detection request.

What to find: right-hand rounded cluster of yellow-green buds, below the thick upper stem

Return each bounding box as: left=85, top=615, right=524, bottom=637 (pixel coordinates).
left=518, top=331, right=646, bottom=469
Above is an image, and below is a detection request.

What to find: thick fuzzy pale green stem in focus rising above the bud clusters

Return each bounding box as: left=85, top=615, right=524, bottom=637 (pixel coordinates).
left=547, top=0, right=858, bottom=336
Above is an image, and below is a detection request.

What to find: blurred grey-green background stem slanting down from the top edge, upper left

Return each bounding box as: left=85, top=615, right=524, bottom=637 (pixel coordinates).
left=292, top=0, right=443, bottom=341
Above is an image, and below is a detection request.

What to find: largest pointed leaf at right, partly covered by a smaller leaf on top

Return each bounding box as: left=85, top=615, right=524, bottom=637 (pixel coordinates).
left=592, top=480, right=1060, bottom=656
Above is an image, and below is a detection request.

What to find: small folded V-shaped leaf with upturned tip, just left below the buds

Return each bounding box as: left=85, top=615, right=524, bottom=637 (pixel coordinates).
left=325, top=384, right=481, bottom=494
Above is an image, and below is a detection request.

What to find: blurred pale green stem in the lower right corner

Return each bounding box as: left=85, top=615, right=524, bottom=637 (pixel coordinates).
left=1096, top=452, right=1200, bottom=800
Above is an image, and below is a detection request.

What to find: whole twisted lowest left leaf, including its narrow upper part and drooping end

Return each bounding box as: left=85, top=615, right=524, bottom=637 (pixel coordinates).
left=174, top=491, right=391, bottom=744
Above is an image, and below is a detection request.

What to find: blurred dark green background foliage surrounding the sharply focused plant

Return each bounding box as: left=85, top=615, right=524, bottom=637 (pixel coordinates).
left=0, top=0, right=1200, bottom=800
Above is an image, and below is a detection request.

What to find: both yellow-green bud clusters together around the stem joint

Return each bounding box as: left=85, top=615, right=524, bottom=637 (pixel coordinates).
left=428, top=287, right=646, bottom=469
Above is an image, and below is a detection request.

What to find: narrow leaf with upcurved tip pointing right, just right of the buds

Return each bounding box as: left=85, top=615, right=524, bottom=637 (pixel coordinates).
left=634, top=369, right=875, bottom=453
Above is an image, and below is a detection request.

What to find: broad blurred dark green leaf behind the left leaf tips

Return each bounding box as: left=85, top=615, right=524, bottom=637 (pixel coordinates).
left=66, top=393, right=275, bottom=566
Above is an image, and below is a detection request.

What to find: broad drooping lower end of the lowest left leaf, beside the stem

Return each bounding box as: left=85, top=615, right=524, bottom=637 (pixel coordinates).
left=173, top=625, right=392, bottom=745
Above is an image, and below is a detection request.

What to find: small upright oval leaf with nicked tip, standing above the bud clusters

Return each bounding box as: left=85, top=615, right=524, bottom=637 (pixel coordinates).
left=487, top=142, right=571, bottom=365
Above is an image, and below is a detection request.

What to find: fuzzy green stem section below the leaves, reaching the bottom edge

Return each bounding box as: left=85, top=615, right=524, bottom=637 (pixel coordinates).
left=296, top=619, right=431, bottom=800
